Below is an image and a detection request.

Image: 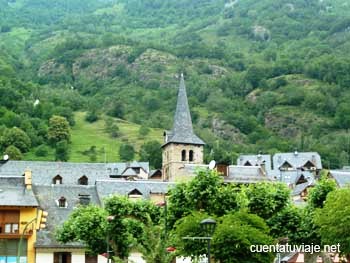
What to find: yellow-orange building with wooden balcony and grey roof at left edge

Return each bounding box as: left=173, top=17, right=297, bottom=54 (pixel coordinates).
left=0, top=171, right=39, bottom=263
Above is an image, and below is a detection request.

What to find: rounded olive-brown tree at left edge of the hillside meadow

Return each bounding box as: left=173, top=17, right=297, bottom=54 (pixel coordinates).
left=47, top=115, right=70, bottom=144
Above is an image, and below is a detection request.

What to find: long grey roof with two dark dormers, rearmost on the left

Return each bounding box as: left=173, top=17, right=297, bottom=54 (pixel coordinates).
left=0, top=161, right=149, bottom=185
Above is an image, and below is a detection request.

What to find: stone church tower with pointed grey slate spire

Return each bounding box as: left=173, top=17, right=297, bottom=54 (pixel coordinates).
left=162, top=74, right=205, bottom=181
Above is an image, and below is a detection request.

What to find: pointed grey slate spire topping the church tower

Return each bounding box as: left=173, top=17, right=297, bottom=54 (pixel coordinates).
left=163, top=74, right=205, bottom=146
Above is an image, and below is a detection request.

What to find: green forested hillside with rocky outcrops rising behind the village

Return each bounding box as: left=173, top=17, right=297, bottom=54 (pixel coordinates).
left=0, top=0, right=350, bottom=167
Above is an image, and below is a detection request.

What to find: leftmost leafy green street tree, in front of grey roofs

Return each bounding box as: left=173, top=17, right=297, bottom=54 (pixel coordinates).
left=56, top=196, right=160, bottom=260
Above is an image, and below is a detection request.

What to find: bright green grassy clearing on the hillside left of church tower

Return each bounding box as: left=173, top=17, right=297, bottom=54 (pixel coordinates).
left=24, top=112, right=162, bottom=162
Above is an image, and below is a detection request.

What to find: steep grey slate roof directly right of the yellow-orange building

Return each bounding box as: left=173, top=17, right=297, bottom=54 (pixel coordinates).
left=33, top=185, right=100, bottom=248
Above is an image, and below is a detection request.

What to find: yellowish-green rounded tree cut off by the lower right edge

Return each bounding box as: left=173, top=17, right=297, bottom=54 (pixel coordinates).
left=314, top=188, right=350, bottom=260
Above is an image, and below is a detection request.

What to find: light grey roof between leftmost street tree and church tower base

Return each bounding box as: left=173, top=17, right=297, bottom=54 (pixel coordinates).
left=96, top=180, right=175, bottom=200
